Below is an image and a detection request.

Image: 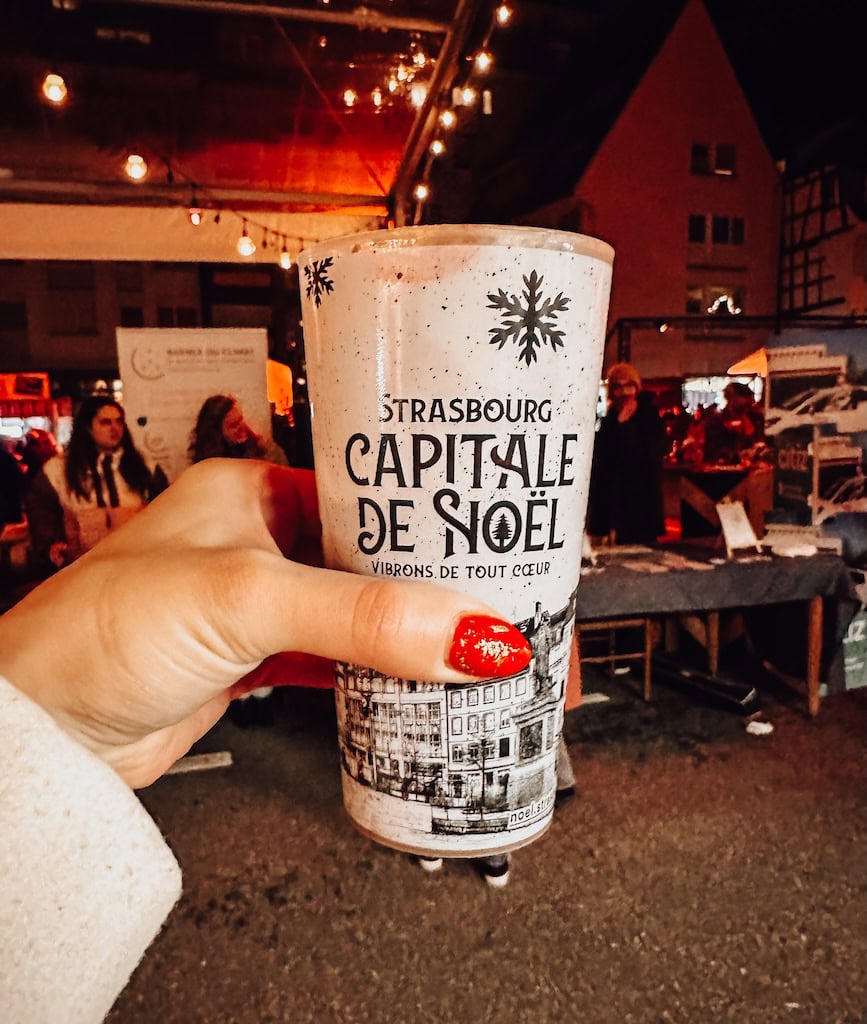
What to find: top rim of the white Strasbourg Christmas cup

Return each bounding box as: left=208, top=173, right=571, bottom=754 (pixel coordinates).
left=298, top=224, right=614, bottom=264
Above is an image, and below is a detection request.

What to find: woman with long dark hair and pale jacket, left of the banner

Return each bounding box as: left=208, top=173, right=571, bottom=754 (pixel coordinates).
left=25, top=395, right=168, bottom=568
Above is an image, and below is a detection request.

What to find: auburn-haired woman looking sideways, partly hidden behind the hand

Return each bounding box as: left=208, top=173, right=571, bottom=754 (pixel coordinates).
left=189, top=394, right=287, bottom=729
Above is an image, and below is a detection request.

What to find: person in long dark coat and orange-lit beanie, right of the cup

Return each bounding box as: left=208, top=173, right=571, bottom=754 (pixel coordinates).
left=588, top=362, right=665, bottom=544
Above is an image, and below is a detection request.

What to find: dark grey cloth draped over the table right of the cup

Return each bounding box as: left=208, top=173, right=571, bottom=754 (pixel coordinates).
left=575, top=554, right=857, bottom=622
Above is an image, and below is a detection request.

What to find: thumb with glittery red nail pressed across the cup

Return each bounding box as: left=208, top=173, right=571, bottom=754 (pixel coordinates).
left=218, top=553, right=531, bottom=683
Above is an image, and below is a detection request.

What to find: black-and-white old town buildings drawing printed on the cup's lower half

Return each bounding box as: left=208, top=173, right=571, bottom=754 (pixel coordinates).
left=337, top=591, right=576, bottom=843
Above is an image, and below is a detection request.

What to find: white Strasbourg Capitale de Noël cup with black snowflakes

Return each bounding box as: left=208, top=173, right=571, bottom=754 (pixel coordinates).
left=299, top=225, right=613, bottom=857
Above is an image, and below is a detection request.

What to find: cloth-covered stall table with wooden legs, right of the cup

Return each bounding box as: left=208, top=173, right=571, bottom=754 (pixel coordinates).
left=575, top=550, right=856, bottom=715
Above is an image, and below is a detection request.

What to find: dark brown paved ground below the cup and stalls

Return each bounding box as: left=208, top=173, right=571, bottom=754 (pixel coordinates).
left=103, top=667, right=867, bottom=1024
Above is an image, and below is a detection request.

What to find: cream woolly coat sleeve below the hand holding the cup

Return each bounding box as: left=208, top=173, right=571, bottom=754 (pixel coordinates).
left=0, top=678, right=180, bottom=1024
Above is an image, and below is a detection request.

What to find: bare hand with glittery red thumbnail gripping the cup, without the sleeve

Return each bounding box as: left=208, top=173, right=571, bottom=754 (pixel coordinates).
left=0, top=460, right=530, bottom=786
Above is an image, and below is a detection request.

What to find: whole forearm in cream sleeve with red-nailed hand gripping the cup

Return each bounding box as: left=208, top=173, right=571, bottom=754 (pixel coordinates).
left=0, top=460, right=530, bottom=1024
